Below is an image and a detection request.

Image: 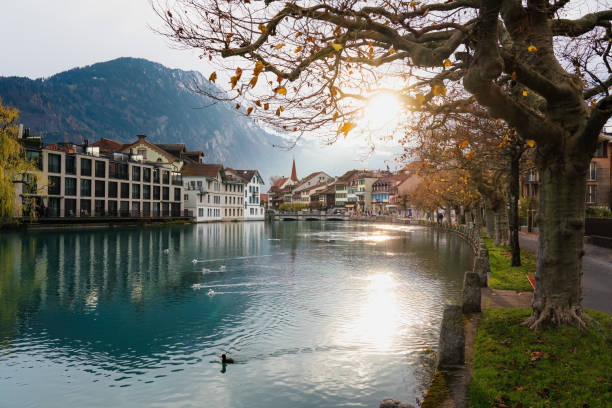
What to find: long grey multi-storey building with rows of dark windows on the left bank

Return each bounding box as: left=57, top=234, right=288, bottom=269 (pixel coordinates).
left=17, top=139, right=185, bottom=217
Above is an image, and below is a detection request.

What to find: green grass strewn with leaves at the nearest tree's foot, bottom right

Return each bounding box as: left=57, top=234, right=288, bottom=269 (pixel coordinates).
left=468, top=309, right=612, bottom=408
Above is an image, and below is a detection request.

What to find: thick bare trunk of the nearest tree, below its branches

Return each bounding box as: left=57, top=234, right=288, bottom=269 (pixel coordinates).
left=525, top=157, right=588, bottom=329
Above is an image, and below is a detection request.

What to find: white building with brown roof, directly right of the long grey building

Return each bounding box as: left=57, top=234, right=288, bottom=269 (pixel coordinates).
left=182, top=163, right=225, bottom=222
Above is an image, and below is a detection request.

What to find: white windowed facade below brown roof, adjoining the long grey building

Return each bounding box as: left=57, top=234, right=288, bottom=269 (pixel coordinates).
left=183, top=176, right=224, bottom=222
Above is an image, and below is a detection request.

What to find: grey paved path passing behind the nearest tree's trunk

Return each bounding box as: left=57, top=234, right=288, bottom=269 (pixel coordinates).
left=519, top=233, right=612, bottom=314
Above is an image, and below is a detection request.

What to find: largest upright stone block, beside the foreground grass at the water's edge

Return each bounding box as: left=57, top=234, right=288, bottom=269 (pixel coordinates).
left=438, top=305, right=465, bottom=368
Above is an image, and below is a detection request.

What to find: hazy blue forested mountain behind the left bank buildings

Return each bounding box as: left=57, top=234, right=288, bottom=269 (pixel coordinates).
left=0, top=58, right=290, bottom=180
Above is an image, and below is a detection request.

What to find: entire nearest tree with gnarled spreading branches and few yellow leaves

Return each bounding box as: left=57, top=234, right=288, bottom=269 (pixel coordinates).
left=156, top=0, right=612, bottom=328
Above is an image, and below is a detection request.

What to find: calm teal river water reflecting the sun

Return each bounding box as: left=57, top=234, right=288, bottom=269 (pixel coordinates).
left=0, top=222, right=472, bottom=408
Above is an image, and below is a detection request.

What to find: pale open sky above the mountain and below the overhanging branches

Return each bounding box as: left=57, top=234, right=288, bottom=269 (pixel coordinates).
left=0, top=0, right=402, bottom=173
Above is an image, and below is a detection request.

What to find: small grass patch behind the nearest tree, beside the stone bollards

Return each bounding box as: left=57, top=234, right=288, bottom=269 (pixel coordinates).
left=484, top=237, right=536, bottom=291
